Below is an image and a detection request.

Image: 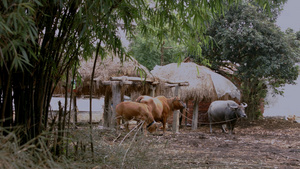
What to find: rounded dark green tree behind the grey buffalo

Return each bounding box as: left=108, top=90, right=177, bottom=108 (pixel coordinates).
left=199, top=3, right=298, bottom=119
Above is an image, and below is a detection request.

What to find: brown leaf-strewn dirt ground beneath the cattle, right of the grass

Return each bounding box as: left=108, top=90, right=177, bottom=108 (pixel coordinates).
left=95, top=118, right=300, bottom=168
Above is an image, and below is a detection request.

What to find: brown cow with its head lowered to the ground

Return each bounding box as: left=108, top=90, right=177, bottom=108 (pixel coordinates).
left=116, top=102, right=157, bottom=135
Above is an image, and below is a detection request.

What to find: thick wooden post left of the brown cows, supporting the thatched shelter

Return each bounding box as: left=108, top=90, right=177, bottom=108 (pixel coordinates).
left=109, top=81, right=121, bottom=128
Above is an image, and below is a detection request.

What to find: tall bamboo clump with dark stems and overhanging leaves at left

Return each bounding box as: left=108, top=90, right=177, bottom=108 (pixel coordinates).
left=0, top=0, right=269, bottom=143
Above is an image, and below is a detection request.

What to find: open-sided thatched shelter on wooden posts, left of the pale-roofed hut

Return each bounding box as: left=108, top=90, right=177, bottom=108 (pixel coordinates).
left=77, top=54, right=170, bottom=127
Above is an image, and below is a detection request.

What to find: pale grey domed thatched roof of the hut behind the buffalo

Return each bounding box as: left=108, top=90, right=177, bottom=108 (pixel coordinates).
left=151, top=62, right=240, bottom=101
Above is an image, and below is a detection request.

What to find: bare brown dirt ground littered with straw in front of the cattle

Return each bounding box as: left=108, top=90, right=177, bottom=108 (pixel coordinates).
left=79, top=118, right=300, bottom=169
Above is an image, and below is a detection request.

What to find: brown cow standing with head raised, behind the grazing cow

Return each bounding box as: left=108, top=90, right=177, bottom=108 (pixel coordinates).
left=136, top=96, right=186, bottom=133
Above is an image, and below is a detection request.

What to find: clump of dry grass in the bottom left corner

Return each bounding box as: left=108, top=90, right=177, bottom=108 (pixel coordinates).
left=0, top=129, right=63, bottom=169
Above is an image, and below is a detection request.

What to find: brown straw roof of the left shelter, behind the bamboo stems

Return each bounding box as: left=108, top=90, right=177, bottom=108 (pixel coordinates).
left=78, top=53, right=155, bottom=95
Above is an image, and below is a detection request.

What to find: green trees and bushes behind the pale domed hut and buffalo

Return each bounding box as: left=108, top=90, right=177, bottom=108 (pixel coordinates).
left=130, top=0, right=300, bottom=119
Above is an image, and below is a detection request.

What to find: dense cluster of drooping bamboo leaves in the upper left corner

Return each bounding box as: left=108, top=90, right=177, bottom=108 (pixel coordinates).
left=0, top=0, right=38, bottom=71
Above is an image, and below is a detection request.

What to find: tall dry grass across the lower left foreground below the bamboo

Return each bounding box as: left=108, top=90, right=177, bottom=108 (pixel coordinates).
left=0, top=126, right=166, bottom=169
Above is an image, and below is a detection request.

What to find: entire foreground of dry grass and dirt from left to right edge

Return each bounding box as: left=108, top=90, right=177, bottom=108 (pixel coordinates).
left=0, top=119, right=300, bottom=169
